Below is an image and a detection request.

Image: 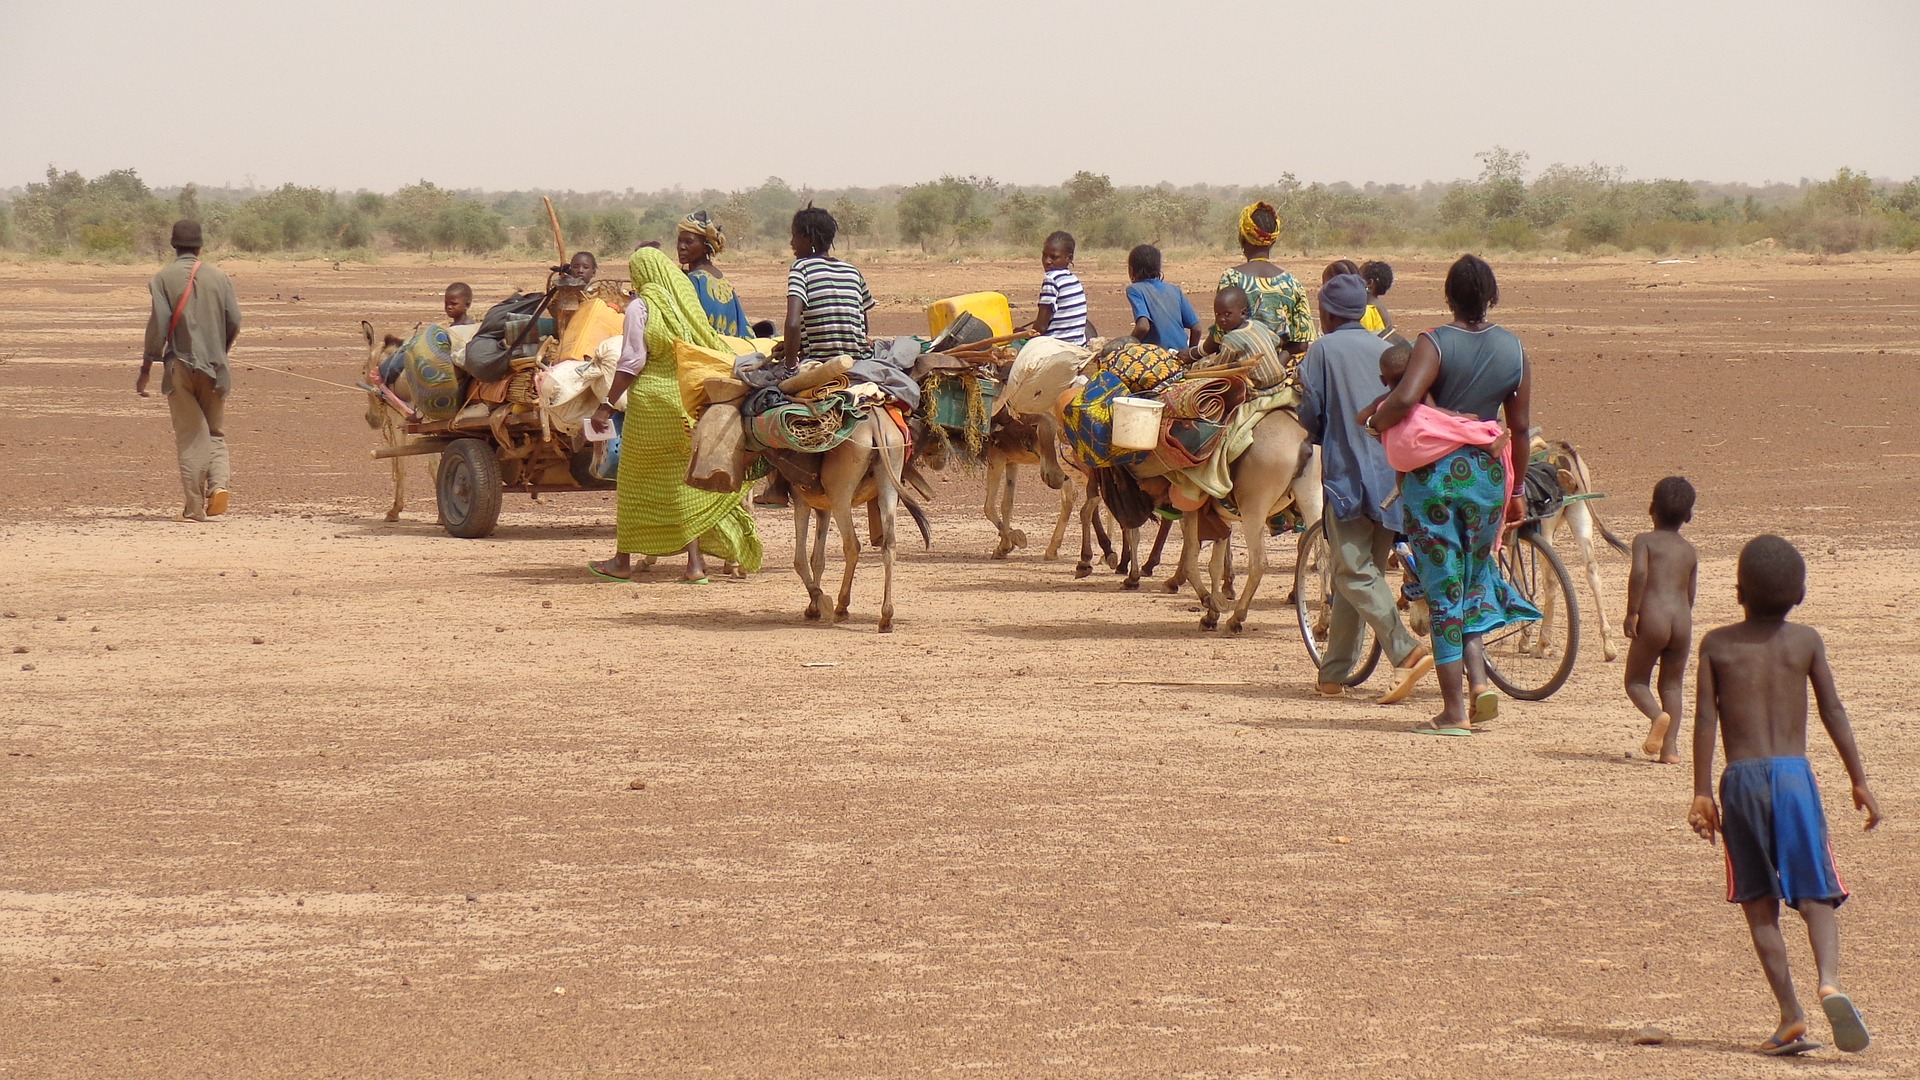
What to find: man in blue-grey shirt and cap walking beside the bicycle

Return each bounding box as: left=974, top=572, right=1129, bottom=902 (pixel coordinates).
left=1300, top=273, right=1434, bottom=705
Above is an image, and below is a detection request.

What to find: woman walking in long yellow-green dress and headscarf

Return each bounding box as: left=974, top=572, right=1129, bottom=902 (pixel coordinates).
left=588, top=248, right=760, bottom=584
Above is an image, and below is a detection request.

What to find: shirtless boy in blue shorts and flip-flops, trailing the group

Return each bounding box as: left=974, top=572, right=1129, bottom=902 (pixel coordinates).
left=1688, top=536, right=1880, bottom=1057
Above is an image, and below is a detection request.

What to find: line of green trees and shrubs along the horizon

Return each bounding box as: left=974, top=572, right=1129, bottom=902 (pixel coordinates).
left=0, top=146, right=1920, bottom=258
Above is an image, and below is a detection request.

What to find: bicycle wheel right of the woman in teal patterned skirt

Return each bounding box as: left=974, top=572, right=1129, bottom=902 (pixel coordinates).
left=1482, top=528, right=1580, bottom=701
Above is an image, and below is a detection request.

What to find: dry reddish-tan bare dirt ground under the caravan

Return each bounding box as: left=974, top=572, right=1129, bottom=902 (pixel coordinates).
left=0, top=247, right=1920, bottom=1078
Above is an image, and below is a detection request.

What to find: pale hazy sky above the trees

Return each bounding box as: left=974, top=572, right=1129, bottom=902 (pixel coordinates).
left=0, top=0, right=1920, bottom=190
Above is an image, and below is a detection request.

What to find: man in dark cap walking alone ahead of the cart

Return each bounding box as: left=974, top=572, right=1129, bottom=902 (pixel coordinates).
left=132, top=221, right=240, bottom=521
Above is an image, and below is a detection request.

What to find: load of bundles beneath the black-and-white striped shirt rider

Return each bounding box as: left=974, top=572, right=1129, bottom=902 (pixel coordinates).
left=674, top=338, right=920, bottom=492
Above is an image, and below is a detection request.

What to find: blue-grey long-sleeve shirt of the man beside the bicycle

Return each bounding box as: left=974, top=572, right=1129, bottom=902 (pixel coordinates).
left=1300, top=323, right=1400, bottom=532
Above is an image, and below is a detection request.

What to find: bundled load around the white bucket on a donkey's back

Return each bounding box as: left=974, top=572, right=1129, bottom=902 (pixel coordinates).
left=1062, top=323, right=1300, bottom=534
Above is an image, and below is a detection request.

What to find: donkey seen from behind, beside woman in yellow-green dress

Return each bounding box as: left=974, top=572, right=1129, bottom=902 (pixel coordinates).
left=766, top=413, right=933, bottom=634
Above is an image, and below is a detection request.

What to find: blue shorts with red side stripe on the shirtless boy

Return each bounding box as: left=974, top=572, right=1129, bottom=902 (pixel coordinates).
left=1720, top=757, right=1847, bottom=909
